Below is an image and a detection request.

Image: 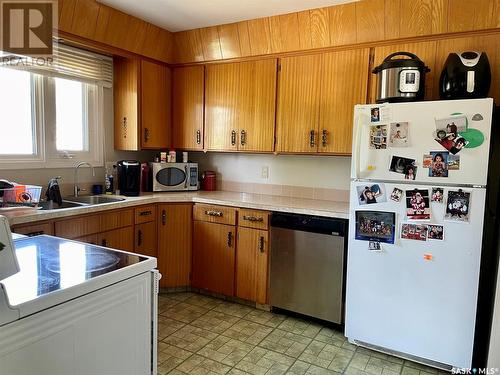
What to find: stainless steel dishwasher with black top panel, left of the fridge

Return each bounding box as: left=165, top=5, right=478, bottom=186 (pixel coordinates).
left=269, top=213, right=347, bottom=324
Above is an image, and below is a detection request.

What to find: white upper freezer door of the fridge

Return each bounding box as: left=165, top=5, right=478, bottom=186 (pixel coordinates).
left=351, top=98, right=493, bottom=186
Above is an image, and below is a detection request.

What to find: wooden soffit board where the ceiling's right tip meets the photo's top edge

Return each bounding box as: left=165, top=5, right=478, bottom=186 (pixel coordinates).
left=354, top=0, right=385, bottom=43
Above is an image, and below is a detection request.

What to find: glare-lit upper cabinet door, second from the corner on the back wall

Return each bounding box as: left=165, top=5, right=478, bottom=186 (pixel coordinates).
left=205, top=64, right=240, bottom=150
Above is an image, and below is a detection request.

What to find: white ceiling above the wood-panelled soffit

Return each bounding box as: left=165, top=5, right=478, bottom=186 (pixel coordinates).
left=98, top=0, right=356, bottom=32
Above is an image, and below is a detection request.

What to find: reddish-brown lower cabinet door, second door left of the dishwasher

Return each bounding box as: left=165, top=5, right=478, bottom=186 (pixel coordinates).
left=193, top=221, right=235, bottom=296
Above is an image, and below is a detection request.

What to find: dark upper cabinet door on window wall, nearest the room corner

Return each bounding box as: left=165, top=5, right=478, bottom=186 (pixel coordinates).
left=141, top=60, right=171, bottom=149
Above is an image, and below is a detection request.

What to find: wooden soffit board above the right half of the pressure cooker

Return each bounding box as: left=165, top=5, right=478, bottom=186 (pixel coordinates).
left=399, top=0, right=434, bottom=38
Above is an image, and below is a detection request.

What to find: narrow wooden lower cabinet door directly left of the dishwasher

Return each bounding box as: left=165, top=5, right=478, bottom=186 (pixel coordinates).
left=236, top=227, right=269, bottom=304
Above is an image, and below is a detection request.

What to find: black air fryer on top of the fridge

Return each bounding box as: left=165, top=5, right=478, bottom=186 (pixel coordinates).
left=439, top=51, right=491, bottom=99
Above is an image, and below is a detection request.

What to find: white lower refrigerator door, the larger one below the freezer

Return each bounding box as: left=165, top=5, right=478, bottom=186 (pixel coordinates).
left=345, top=182, right=486, bottom=368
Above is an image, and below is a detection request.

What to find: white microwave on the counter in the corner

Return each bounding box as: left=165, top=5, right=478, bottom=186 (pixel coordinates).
left=150, top=163, right=198, bottom=191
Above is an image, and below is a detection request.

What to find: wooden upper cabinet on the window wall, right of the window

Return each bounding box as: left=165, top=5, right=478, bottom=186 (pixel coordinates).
left=113, top=57, right=171, bottom=151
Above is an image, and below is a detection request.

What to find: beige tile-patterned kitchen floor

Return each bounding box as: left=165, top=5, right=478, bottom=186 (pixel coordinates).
left=158, top=293, right=450, bottom=375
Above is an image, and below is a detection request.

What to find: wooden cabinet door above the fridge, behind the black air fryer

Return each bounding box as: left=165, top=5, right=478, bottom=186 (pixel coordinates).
left=434, top=34, right=500, bottom=102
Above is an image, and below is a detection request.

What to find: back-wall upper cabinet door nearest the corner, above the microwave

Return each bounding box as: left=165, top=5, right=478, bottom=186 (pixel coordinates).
left=172, top=66, right=205, bottom=150
